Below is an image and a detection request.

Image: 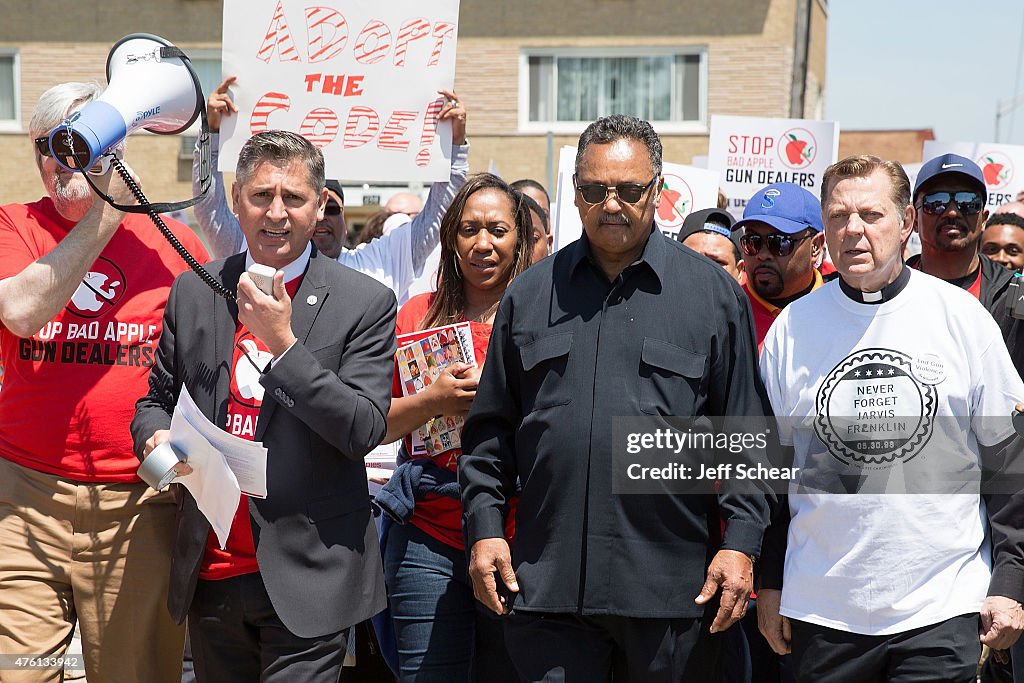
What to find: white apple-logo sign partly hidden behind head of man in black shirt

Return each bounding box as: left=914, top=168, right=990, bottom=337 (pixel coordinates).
left=552, top=146, right=719, bottom=251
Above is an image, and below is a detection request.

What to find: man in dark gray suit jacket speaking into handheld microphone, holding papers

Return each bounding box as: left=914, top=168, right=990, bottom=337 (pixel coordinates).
left=131, top=131, right=395, bottom=683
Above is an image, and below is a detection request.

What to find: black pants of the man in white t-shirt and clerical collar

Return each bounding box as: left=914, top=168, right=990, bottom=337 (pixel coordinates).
left=790, top=613, right=981, bottom=683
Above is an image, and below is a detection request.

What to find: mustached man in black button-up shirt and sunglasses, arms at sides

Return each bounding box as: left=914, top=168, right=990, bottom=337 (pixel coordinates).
left=459, top=116, right=770, bottom=681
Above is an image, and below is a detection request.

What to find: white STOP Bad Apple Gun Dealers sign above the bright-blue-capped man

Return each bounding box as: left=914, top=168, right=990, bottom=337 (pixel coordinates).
left=708, top=116, right=839, bottom=216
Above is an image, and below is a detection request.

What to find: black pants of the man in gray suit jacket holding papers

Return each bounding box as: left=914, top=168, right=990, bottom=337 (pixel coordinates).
left=188, top=573, right=347, bottom=683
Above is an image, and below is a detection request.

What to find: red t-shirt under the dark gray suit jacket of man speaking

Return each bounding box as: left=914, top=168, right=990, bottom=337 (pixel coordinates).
left=199, top=276, right=302, bottom=581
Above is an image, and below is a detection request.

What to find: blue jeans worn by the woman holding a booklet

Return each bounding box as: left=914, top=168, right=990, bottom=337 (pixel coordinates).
left=384, top=524, right=518, bottom=683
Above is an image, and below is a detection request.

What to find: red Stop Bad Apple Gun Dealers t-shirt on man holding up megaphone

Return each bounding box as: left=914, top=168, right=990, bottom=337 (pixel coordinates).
left=0, top=198, right=208, bottom=481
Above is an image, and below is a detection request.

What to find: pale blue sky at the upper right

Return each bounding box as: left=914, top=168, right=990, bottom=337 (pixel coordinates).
left=825, top=0, right=1024, bottom=144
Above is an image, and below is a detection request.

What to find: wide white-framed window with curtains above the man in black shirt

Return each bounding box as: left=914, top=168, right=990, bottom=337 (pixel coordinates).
left=519, top=49, right=707, bottom=132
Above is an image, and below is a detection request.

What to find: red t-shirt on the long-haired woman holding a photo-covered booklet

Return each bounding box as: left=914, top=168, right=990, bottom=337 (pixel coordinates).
left=391, top=292, right=517, bottom=549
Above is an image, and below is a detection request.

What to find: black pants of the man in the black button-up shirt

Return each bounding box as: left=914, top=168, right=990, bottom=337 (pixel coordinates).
left=505, top=611, right=722, bottom=683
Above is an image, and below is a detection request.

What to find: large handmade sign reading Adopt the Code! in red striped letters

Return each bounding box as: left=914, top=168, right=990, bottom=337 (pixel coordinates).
left=219, top=0, right=459, bottom=182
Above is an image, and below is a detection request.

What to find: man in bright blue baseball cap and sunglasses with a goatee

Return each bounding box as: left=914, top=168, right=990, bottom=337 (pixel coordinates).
left=732, top=182, right=824, bottom=348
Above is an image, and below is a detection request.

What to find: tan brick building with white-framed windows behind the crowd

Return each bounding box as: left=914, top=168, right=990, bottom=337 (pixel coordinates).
left=0, top=0, right=827, bottom=219
